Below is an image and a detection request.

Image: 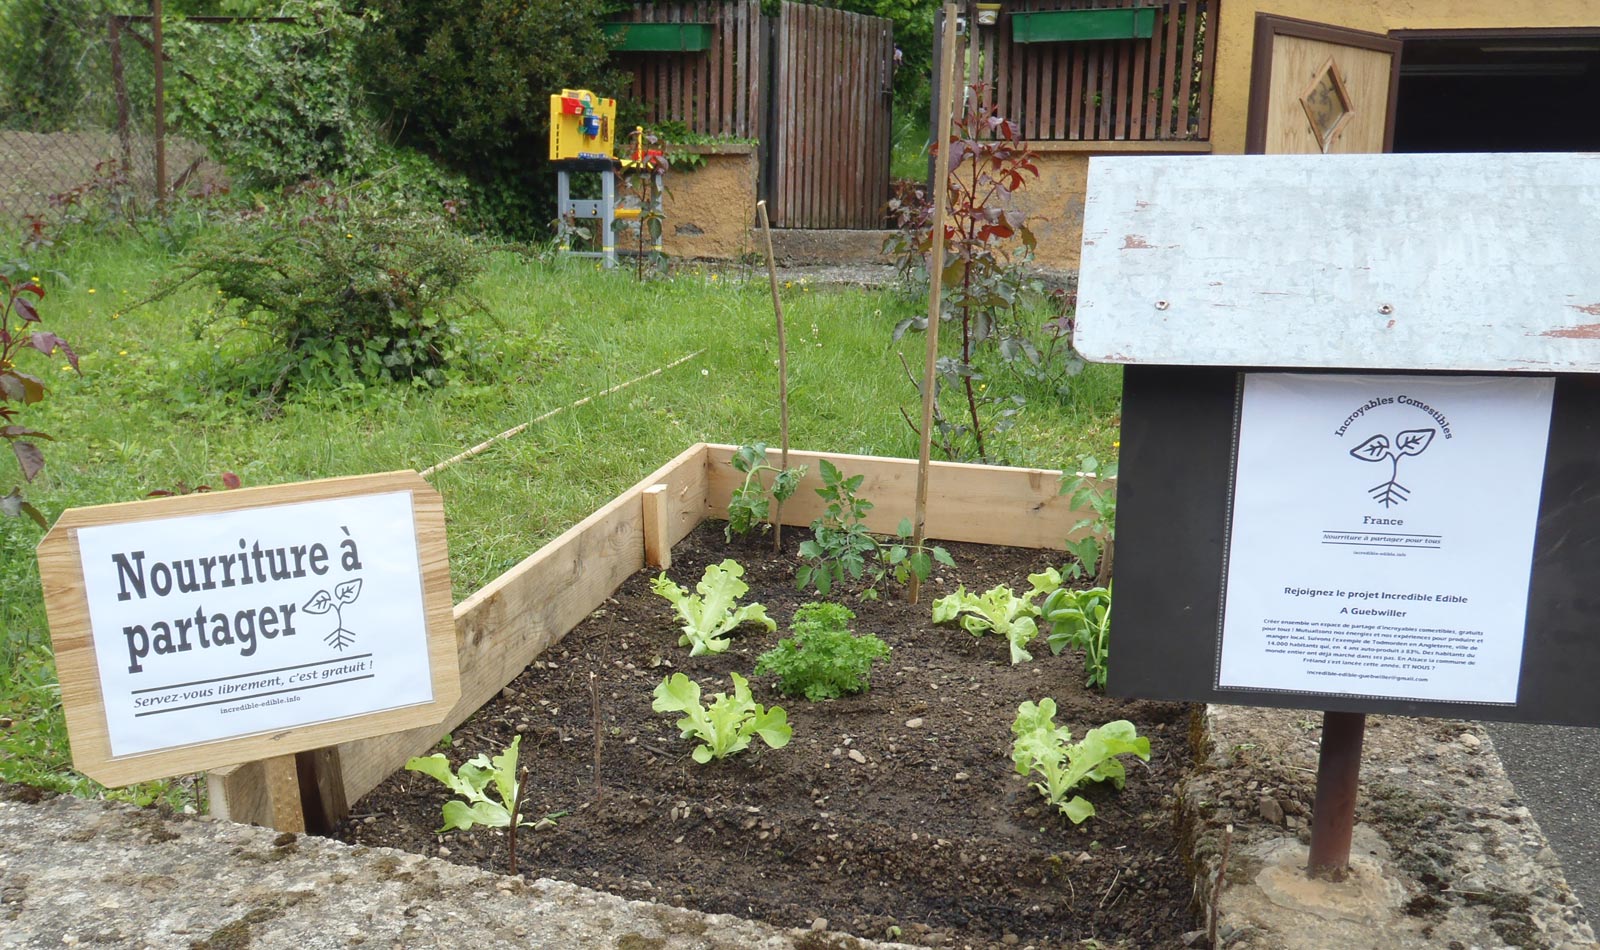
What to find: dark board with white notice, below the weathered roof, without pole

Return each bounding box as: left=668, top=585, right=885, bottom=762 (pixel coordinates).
left=1107, top=366, right=1600, bottom=726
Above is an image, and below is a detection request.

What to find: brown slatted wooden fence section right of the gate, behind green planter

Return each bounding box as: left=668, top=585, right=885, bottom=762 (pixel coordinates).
left=963, top=0, right=1221, bottom=141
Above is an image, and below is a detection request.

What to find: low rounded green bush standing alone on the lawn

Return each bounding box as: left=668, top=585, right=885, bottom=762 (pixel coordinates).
left=158, top=181, right=482, bottom=393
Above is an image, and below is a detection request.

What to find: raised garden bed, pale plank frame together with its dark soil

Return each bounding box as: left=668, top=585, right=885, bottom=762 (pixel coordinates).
left=211, top=446, right=1197, bottom=947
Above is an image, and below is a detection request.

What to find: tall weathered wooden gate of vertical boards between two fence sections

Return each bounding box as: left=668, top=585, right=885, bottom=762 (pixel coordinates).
left=766, top=2, right=894, bottom=227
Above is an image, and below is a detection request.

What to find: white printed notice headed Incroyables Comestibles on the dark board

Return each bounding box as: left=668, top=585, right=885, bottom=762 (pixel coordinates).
left=1218, top=374, right=1554, bottom=704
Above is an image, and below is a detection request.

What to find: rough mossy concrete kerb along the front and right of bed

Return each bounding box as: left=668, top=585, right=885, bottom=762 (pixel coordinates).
left=0, top=707, right=1600, bottom=950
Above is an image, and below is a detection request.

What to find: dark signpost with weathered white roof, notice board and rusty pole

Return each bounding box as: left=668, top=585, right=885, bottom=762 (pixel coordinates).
left=1074, top=154, right=1600, bottom=878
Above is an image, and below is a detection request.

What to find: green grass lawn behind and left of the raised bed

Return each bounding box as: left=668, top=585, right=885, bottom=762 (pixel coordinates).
left=0, top=225, right=1120, bottom=801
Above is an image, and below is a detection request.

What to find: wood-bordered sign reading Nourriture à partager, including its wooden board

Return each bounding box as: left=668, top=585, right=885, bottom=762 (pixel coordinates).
left=38, top=472, right=459, bottom=785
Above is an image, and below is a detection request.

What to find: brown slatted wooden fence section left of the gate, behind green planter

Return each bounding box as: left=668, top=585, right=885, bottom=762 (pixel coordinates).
left=616, top=0, right=770, bottom=139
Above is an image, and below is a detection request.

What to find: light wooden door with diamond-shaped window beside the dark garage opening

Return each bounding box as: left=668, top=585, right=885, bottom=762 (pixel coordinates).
left=1246, top=14, right=1400, bottom=154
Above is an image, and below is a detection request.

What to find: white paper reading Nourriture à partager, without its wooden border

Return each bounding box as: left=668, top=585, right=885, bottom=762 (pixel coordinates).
left=78, top=491, right=432, bottom=756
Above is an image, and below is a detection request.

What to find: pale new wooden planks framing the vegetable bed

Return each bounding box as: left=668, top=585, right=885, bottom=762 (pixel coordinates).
left=208, top=443, right=1094, bottom=827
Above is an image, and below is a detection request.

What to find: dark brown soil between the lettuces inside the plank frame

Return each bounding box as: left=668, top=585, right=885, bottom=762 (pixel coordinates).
left=341, top=523, right=1198, bottom=948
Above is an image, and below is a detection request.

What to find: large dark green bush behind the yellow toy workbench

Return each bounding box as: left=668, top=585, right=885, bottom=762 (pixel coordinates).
left=358, top=0, right=626, bottom=237
